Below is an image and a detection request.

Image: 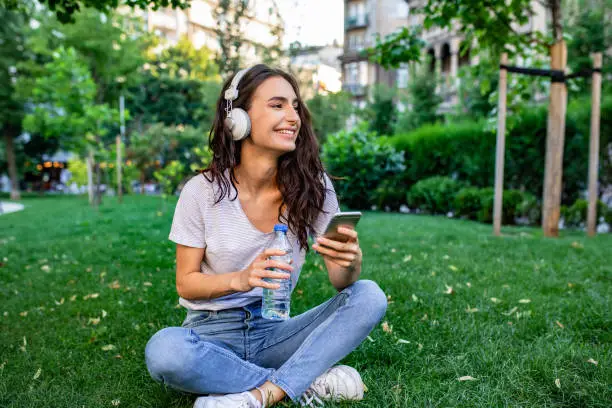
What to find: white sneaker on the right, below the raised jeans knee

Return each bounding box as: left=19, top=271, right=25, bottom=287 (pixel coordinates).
left=300, top=365, right=366, bottom=407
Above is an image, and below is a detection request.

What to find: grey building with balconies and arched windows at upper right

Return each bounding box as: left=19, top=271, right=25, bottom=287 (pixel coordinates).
left=341, top=0, right=547, bottom=111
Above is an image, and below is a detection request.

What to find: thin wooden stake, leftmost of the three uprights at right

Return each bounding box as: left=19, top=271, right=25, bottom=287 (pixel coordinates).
left=493, top=53, right=508, bottom=236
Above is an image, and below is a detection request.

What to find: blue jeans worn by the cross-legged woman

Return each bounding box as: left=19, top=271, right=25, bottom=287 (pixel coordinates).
left=145, top=280, right=387, bottom=401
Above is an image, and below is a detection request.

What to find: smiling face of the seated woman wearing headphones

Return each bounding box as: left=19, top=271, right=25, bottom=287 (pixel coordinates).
left=248, top=77, right=301, bottom=153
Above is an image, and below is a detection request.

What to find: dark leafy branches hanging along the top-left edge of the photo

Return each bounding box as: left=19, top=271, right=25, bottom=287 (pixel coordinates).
left=0, top=0, right=191, bottom=23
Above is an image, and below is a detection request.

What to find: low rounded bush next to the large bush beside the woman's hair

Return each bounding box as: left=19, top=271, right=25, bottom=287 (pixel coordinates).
left=406, top=177, right=465, bottom=214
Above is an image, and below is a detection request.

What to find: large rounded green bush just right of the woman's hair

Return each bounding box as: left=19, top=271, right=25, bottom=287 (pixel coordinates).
left=322, top=123, right=405, bottom=209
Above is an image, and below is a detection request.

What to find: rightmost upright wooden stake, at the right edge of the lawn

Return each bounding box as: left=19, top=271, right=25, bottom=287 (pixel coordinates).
left=587, top=52, right=602, bottom=237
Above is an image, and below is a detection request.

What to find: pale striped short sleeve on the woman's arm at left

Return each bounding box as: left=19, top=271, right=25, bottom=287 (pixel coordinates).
left=168, top=176, right=206, bottom=248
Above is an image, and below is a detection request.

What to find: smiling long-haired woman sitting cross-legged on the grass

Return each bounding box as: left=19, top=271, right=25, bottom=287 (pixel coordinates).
left=145, top=65, right=387, bottom=408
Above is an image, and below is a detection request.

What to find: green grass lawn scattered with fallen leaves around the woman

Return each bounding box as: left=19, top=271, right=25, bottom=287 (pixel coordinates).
left=0, top=196, right=612, bottom=408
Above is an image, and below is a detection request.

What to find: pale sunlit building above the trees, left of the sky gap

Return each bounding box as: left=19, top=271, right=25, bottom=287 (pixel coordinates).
left=134, top=0, right=283, bottom=64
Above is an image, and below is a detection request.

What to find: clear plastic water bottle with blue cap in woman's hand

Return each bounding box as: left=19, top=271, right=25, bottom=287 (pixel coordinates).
left=261, top=224, right=293, bottom=320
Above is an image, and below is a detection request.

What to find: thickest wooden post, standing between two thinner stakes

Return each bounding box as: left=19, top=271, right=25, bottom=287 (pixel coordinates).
left=542, top=41, right=567, bottom=237
